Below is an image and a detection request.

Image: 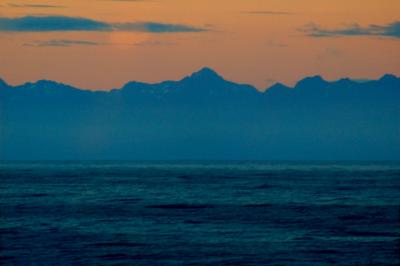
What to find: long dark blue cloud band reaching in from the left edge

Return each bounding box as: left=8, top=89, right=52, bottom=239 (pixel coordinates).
left=0, top=16, right=208, bottom=33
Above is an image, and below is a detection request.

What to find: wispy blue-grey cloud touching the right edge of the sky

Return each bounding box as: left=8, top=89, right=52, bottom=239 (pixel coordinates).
left=300, top=21, right=400, bottom=38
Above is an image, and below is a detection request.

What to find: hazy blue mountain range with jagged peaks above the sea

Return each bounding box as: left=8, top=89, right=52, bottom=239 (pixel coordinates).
left=0, top=68, right=400, bottom=160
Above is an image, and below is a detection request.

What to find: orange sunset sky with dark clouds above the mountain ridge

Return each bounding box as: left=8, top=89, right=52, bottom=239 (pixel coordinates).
left=0, top=0, right=400, bottom=90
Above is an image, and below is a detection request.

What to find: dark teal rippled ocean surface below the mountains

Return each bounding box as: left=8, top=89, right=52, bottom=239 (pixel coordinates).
left=0, top=162, right=400, bottom=265
